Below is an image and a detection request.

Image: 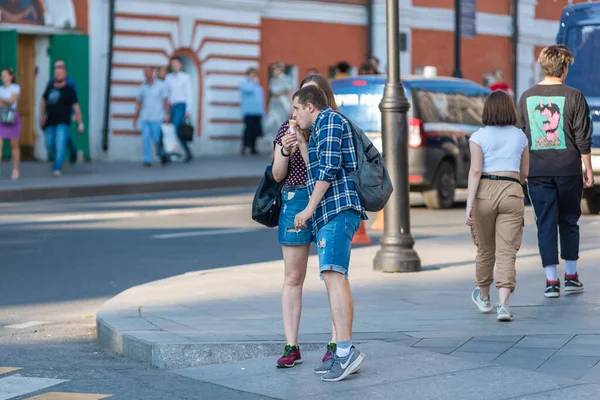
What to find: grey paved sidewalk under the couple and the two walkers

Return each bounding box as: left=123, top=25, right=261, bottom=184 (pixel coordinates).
left=97, top=210, right=600, bottom=400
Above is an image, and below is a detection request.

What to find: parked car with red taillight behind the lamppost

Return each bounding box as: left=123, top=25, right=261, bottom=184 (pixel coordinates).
left=331, top=75, right=490, bottom=209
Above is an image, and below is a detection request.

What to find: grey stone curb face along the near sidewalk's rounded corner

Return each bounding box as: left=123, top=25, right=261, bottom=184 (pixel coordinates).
left=96, top=315, right=332, bottom=370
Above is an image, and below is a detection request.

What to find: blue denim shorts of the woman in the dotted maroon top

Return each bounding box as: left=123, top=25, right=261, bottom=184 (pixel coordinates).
left=278, top=185, right=312, bottom=246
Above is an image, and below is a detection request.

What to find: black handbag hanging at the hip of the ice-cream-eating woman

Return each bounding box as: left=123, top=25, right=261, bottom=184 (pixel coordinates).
left=252, top=165, right=283, bottom=228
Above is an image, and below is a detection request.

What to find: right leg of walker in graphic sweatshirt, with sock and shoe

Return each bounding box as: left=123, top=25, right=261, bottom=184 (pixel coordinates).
left=556, top=176, right=583, bottom=293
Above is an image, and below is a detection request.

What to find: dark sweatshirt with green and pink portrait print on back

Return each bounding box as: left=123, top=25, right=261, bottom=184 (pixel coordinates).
left=517, top=84, right=593, bottom=177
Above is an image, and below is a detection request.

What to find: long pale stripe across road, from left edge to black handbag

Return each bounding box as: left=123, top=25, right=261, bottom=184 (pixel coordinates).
left=0, top=204, right=250, bottom=225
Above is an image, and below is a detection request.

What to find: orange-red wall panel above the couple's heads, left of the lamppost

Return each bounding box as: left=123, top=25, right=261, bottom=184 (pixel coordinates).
left=260, top=18, right=367, bottom=85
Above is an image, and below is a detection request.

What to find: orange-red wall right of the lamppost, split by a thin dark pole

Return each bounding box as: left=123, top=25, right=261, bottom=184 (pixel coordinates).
left=412, top=29, right=513, bottom=84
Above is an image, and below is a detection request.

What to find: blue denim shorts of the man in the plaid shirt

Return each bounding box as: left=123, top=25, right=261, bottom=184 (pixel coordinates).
left=316, top=210, right=362, bottom=279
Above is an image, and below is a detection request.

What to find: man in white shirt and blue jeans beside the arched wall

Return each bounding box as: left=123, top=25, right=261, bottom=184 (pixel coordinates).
left=165, top=57, right=192, bottom=162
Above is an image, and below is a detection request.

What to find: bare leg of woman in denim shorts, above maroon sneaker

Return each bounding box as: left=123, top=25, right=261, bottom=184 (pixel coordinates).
left=281, top=245, right=310, bottom=345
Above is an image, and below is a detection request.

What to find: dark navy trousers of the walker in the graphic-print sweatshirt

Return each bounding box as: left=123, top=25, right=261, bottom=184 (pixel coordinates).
left=527, top=175, right=583, bottom=267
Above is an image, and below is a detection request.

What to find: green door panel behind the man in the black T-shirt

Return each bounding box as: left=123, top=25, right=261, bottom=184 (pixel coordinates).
left=50, top=34, right=90, bottom=160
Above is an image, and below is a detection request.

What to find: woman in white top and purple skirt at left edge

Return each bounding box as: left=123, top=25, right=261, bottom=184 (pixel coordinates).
left=0, top=68, right=21, bottom=180
